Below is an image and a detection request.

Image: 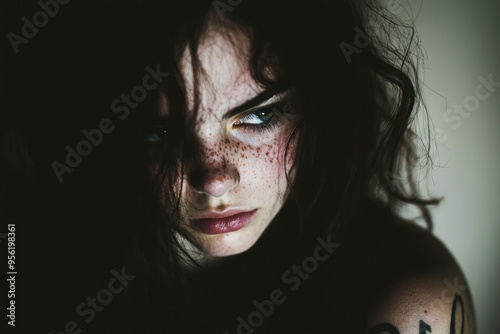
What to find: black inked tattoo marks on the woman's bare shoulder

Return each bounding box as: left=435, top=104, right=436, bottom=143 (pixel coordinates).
left=367, top=294, right=465, bottom=334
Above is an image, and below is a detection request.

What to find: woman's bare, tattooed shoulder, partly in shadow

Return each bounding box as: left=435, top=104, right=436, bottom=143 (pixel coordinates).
left=352, top=222, right=475, bottom=334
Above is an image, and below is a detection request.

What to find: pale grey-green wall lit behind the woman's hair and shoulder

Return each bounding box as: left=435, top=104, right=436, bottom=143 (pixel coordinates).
left=394, top=0, right=500, bottom=334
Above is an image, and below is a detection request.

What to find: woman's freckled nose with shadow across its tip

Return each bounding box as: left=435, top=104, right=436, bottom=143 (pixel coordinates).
left=187, top=142, right=240, bottom=197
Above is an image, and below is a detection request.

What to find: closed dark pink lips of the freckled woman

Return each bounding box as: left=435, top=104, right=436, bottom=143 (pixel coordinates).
left=190, top=209, right=257, bottom=234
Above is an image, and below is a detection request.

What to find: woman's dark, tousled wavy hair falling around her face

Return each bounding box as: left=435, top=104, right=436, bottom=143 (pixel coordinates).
left=126, top=0, right=437, bottom=277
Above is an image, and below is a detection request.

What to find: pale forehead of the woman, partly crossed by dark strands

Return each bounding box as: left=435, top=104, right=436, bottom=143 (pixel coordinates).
left=179, top=27, right=263, bottom=117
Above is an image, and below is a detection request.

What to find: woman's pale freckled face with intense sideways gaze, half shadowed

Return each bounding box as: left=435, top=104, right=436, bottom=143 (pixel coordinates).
left=154, top=26, right=297, bottom=257
